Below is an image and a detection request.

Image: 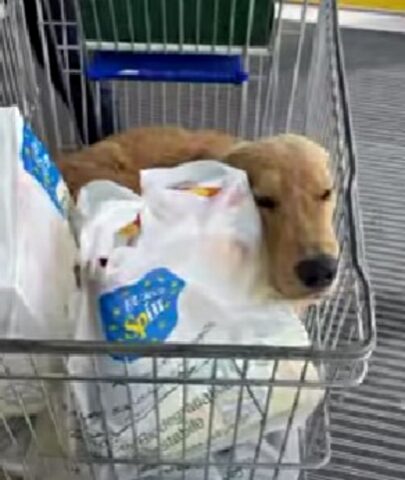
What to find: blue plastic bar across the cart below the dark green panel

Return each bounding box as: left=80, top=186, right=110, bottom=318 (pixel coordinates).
left=87, top=51, right=248, bottom=85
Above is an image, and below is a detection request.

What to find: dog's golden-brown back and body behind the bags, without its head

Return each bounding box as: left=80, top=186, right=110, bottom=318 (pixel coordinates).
left=57, top=127, right=235, bottom=197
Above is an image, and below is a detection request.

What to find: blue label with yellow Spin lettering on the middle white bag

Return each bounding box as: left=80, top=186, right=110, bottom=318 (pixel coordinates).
left=99, top=268, right=185, bottom=359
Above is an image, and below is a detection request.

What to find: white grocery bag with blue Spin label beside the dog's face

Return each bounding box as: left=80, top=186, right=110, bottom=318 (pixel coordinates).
left=69, top=161, right=322, bottom=480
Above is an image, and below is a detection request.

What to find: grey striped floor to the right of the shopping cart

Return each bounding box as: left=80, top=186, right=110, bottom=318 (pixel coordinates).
left=308, top=30, right=405, bottom=480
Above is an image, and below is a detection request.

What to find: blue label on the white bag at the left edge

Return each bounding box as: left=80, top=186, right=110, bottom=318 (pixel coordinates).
left=21, top=124, right=69, bottom=217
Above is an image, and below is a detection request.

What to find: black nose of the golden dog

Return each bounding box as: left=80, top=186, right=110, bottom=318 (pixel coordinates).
left=295, top=255, right=337, bottom=289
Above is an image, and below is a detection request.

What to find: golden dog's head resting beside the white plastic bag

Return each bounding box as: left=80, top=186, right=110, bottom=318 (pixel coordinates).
left=225, top=135, right=338, bottom=299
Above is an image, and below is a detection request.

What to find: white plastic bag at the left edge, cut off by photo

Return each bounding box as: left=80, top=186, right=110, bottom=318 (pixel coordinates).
left=0, top=107, right=76, bottom=415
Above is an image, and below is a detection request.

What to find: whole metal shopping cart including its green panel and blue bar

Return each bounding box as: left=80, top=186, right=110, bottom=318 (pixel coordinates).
left=0, top=0, right=375, bottom=480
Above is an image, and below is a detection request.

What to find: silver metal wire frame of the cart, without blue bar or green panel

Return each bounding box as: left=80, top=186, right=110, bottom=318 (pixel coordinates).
left=0, top=0, right=376, bottom=479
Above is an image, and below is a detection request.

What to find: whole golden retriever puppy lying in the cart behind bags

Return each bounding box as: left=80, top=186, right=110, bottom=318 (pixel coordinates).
left=58, top=127, right=338, bottom=300
